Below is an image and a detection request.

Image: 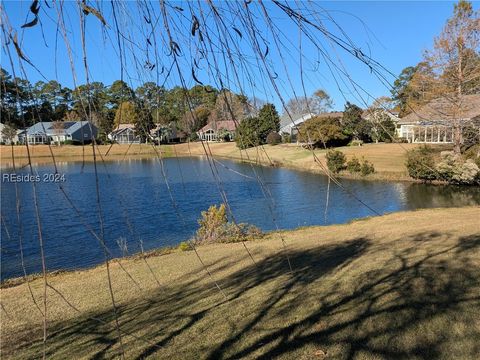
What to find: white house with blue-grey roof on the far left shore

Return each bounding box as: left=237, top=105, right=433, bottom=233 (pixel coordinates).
left=24, top=121, right=98, bottom=145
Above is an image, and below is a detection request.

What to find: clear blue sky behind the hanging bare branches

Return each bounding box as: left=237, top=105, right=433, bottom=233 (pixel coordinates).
left=1, top=1, right=479, bottom=110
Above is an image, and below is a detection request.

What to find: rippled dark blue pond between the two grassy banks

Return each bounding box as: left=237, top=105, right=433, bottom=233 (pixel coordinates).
left=1, top=158, right=480, bottom=280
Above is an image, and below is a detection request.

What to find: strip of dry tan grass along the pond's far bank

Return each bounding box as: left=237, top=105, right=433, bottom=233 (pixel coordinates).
left=0, top=142, right=438, bottom=180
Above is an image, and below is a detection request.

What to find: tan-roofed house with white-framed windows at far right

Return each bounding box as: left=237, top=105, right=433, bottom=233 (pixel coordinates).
left=397, top=94, right=480, bottom=144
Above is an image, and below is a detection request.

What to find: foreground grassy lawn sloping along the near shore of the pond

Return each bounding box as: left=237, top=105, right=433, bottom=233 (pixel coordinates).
left=1, top=207, right=480, bottom=359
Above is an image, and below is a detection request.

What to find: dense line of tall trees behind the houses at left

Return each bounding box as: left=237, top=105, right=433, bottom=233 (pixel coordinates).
left=0, top=69, right=258, bottom=140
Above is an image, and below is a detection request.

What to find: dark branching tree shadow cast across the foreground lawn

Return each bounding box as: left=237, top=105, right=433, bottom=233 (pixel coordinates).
left=6, top=232, right=480, bottom=359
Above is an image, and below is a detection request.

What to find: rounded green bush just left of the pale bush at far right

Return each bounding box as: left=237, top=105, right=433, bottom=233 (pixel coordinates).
left=405, top=146, right=438, bottom=181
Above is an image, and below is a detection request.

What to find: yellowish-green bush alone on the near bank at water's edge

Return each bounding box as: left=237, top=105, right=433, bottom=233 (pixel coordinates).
left=196, top=204, right=263, bottom=244
